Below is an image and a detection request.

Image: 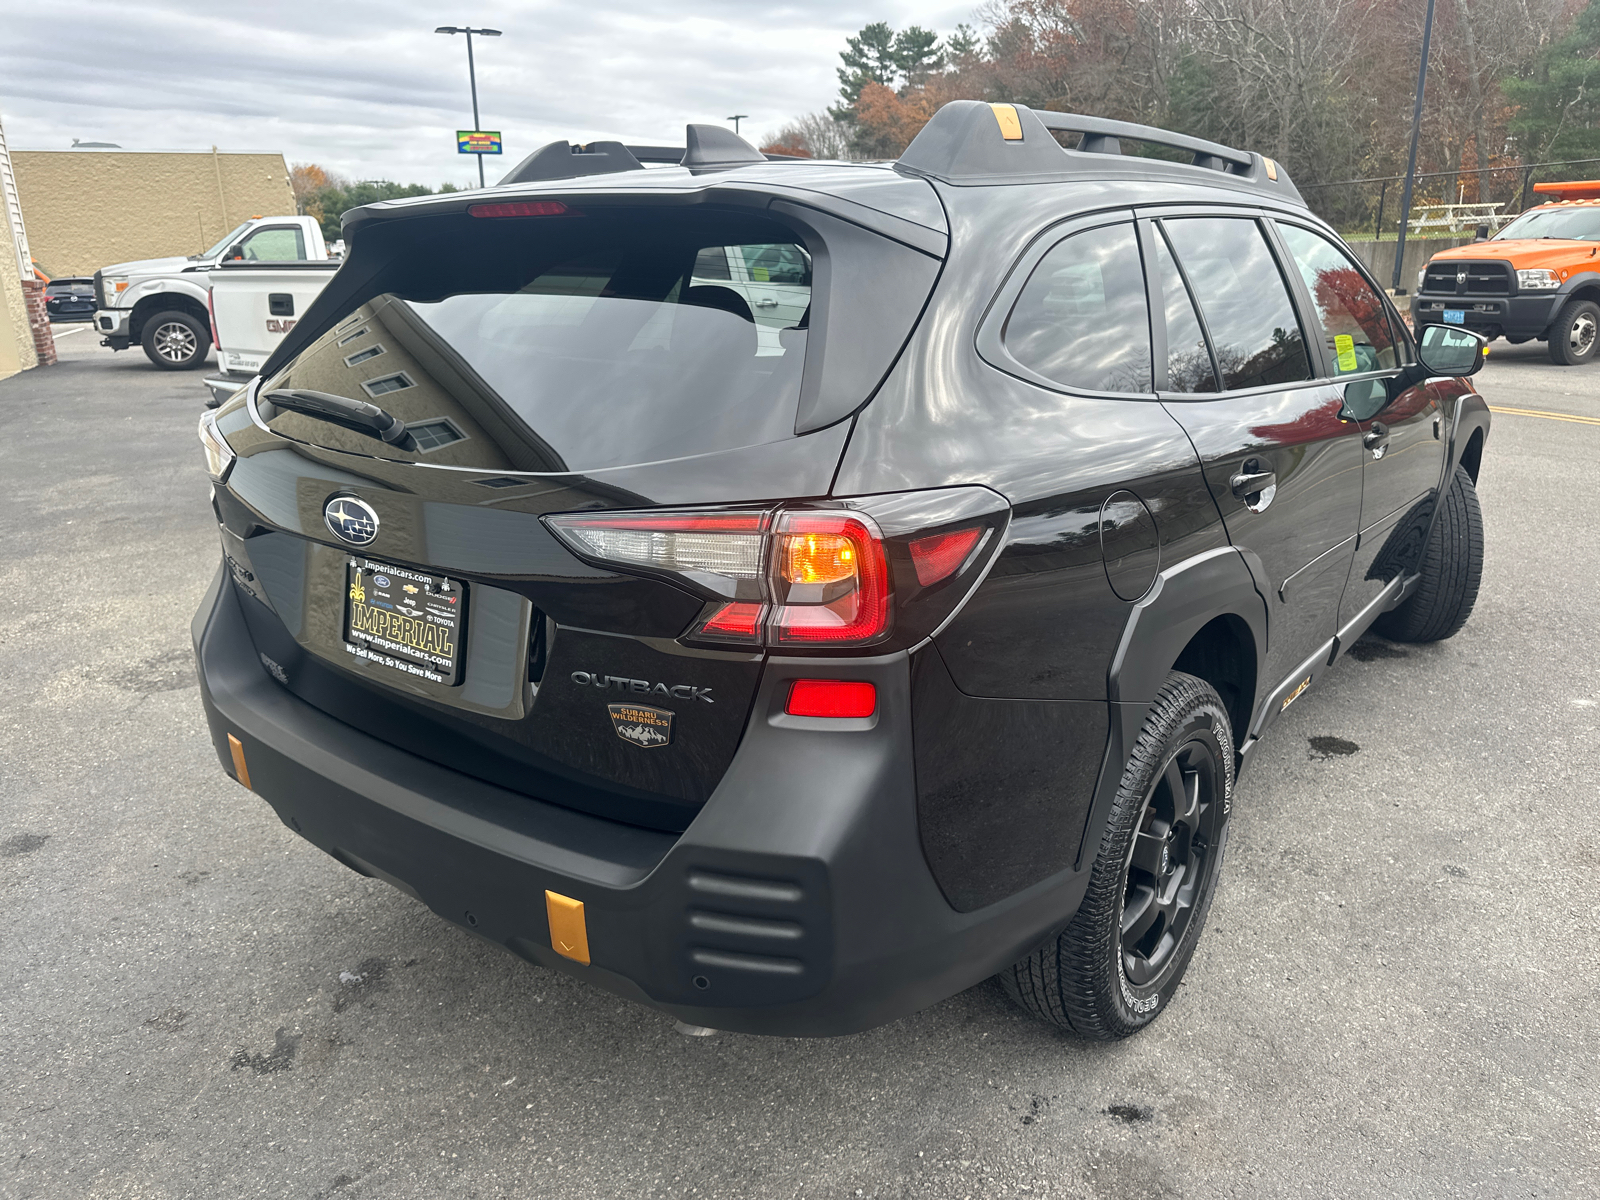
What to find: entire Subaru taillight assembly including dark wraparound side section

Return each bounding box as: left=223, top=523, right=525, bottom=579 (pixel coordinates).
left=544, top=486, right=1010, bottom=653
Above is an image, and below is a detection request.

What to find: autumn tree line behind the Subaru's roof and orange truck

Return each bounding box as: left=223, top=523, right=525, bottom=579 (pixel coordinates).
left=763, top=0, right=1600, bottom=233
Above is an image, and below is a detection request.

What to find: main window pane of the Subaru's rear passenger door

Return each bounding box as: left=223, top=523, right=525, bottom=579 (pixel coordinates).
left=1163, top=216, right=1310, bottom=390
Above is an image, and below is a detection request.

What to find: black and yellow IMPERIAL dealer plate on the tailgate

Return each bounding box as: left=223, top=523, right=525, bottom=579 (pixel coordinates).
left=344, top=558, right=467, bottom=685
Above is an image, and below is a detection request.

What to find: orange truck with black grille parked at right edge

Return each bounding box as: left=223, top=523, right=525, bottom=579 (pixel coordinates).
left=1411, top=179, right=1600, bottom=366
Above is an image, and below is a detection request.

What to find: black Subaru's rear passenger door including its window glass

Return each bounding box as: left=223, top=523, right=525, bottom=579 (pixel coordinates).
left=1142, top=211, right=1363, bottom=733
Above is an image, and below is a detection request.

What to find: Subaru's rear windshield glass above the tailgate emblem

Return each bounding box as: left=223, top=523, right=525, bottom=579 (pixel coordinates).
left=262, top=213, right=811, bottom=470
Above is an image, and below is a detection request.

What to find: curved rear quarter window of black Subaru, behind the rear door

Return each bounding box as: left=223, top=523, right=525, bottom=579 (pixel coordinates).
left=1003, top=224, right=1154, bottom=392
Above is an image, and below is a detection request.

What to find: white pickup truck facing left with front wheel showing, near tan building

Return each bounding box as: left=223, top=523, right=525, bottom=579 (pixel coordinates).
left=94, top=216, right=328, bottom=371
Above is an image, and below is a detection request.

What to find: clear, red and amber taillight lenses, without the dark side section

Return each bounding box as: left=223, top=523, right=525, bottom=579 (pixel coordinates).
left=544, top=509, right=893, bottom=646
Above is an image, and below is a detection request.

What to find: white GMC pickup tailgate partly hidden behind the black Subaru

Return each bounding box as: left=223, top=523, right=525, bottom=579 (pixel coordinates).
left=205, top=261, right=339, bottom=408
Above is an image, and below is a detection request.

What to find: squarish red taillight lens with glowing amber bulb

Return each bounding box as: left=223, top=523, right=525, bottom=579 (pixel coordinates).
left=768, top=512, right=891, bottom=645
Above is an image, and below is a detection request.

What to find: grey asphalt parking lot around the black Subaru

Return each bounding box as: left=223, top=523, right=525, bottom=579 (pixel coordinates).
left=0, top=331, right=1600, bottom=1200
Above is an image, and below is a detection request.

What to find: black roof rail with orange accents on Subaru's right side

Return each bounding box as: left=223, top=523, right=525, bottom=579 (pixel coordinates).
left=898, top=101, right=1304, bottom=203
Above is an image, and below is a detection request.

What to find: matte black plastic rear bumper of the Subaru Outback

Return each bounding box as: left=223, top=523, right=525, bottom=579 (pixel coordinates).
left=194, top=571, right=1086, bottom=1035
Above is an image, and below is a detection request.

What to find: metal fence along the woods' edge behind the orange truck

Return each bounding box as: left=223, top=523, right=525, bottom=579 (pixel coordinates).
left=1299, top=158, right=1600, bottom=240
